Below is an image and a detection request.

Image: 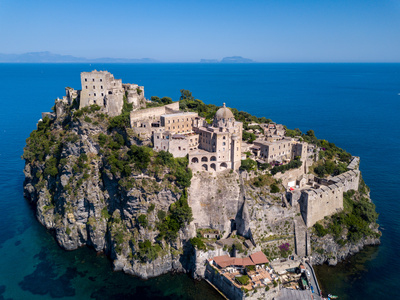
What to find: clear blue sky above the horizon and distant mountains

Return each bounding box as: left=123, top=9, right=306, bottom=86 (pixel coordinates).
left=0, top=0, right=400, bottom=62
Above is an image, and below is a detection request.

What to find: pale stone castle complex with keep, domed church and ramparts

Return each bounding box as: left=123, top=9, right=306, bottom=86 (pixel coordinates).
left=55, top=70, right=360, bottom=227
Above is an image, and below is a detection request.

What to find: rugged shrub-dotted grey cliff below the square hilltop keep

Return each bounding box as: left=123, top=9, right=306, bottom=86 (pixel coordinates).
left=24, top=104, right=194, bottom=278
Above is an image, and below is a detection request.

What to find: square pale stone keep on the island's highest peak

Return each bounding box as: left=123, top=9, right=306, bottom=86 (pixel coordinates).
left=79, top=70, right=145, bottom=116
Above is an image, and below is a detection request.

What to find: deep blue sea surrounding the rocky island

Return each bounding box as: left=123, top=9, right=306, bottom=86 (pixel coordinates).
left=0, top=63, right=400, bottom=299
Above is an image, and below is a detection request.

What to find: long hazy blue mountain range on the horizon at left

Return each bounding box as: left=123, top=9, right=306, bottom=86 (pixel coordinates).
left=0, top=51, right=158, bottom=63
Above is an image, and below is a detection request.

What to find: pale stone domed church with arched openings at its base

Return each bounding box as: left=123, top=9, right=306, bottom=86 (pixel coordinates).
left=189, top=103, right=243, bottom=172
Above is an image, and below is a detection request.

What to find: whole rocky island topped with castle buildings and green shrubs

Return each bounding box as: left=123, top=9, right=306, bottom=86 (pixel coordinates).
left=23, top=71, right=381, bottom=299
